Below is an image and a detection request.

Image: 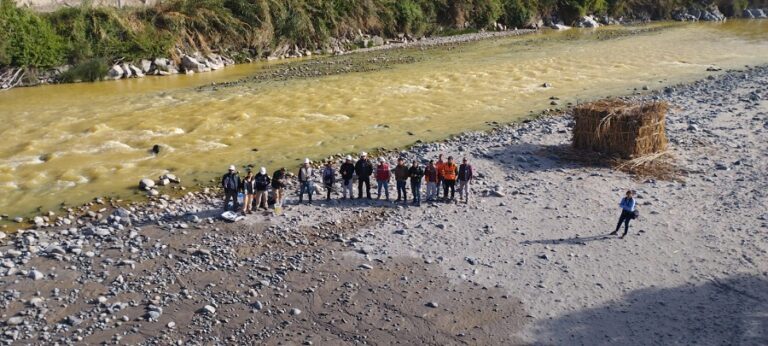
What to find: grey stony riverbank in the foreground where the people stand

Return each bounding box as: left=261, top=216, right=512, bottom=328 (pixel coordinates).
left=0, top=67, right=768, bottom=345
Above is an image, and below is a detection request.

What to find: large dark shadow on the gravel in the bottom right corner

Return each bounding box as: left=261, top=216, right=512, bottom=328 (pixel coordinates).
left=535, top=273, right=768, bottom=345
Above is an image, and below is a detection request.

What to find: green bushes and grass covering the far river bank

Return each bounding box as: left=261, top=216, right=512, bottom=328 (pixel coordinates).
left=0, top=0, right=768, bottom=71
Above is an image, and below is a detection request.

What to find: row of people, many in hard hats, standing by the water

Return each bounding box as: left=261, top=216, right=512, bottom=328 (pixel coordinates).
left=221, top=152, right=474, bottom=214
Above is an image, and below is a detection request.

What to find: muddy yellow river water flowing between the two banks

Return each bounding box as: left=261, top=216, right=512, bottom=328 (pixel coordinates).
left=0, top=21, right=768, bottom=216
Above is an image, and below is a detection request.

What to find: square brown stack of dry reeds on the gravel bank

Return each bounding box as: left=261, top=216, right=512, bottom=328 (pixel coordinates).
left=573, top=100, right=668, bottom=159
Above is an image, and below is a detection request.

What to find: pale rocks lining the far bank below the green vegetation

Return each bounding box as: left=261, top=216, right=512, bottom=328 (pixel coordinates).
left=6, top=6, right=768, bottom=90
